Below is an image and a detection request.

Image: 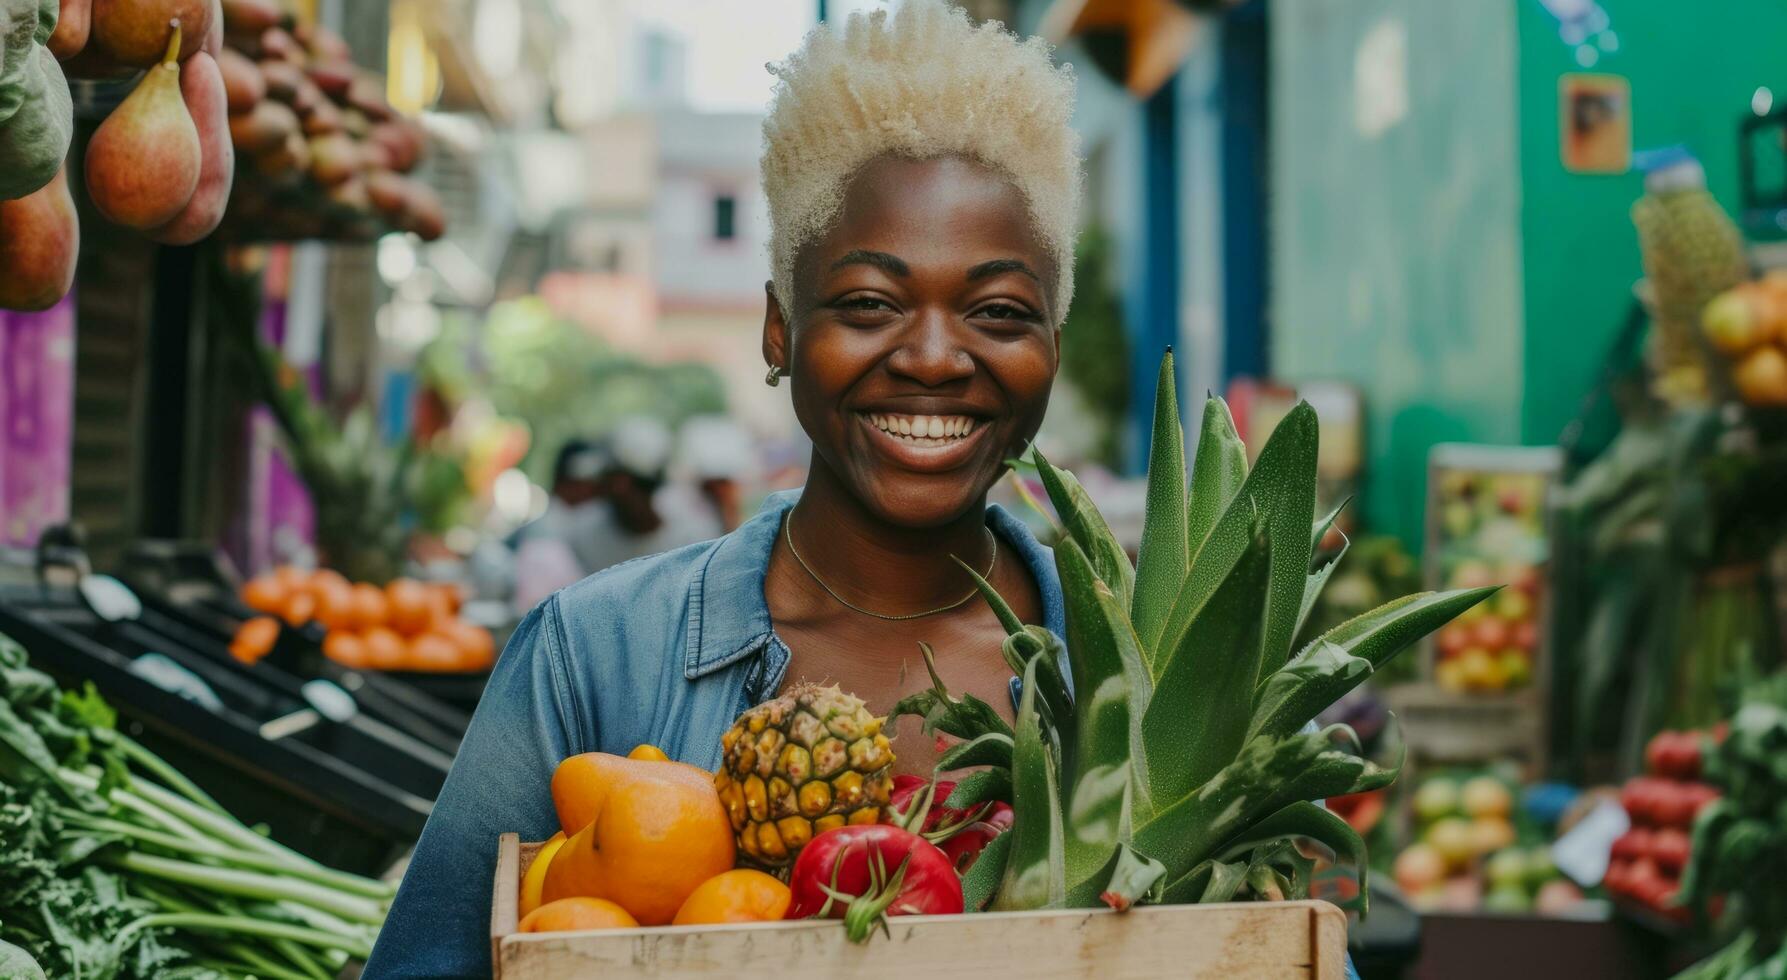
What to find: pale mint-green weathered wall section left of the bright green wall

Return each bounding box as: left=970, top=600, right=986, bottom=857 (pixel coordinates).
left=1269, top=0, right=1524, bottom=544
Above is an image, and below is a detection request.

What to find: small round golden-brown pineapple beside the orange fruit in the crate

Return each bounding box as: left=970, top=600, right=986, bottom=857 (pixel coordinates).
left=713, top=683, right=894, bottom=869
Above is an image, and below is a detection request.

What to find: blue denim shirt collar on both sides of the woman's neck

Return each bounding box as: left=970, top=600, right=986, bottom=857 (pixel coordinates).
left=683, top=490, right=1067, bottom=680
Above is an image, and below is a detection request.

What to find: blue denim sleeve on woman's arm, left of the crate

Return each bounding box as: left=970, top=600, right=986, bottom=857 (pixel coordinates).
left=365, top=597, right=581, bottom=980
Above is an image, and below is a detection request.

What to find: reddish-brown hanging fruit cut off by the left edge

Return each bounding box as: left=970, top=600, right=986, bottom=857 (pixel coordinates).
left=0, top=166, right=80, bottom=313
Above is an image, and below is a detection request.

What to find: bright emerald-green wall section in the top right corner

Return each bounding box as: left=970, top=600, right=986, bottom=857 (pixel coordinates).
left=1517, top=0, right=1787, bottom=444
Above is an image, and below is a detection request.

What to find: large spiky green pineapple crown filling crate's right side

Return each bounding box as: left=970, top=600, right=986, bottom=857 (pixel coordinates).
left=890, top=352, right=1494, bottom=908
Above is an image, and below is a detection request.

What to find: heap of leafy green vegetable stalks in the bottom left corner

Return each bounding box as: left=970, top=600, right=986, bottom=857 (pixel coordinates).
left=0, top=633, right=395, bottom=980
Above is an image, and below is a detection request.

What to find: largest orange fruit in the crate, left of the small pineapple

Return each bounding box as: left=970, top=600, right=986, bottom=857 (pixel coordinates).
left=541, top=753, right=734, bottom=926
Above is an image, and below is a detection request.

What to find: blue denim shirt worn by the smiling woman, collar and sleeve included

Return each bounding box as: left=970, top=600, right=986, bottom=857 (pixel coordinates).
left=365, top=494, right=1067, bottom=980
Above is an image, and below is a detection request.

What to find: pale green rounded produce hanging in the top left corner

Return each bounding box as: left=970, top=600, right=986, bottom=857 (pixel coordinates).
left=0, top=0, right=75, bottom=200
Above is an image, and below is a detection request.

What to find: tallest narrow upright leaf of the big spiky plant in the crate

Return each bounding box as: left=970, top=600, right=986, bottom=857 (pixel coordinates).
left=1129, top=349, right=1192, bottom=660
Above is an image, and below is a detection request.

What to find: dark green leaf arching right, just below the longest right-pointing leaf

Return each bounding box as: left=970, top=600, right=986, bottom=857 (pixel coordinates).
left=1135, top=731, right=1399, bottom=876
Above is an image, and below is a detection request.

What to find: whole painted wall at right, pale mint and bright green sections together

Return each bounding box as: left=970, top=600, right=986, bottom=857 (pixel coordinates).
left=1271, top=0, right=1787, bottom=544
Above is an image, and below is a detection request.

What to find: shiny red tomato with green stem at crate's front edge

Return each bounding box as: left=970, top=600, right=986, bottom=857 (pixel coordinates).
left=786, top=824, right=961, bottom=941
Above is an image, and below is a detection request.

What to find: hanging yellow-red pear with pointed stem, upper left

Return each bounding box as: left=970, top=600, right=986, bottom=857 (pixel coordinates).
left=86, top=21, right=202, bottom=231
